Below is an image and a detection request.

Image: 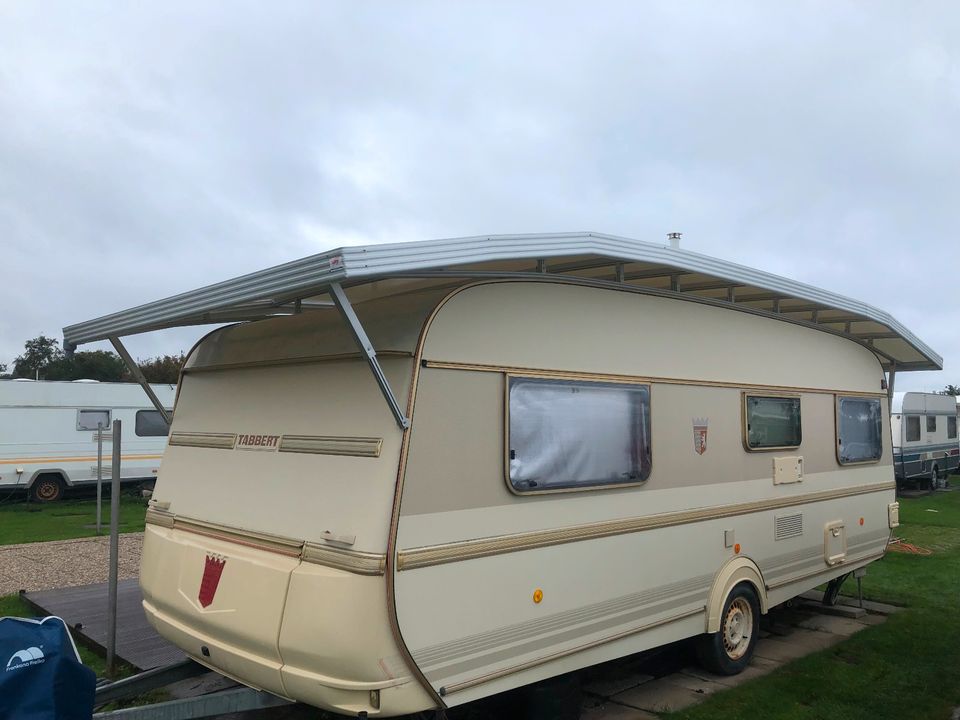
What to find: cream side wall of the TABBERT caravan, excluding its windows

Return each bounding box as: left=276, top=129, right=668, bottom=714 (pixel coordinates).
left=396, top=282, right=894, bottom=704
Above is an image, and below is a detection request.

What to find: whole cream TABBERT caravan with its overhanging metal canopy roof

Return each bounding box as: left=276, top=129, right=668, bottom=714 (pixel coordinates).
left=64, top=234, right=941, bottom=717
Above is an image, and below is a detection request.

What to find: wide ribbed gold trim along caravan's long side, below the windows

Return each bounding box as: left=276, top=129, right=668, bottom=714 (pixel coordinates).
left=397, top=482, right=896, bottom=570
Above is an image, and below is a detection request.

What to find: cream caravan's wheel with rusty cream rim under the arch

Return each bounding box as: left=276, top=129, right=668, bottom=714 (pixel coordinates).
left=697, top=583, right=760, bottom=675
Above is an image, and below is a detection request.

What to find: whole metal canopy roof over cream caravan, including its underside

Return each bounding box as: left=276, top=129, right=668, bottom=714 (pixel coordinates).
left=63, top=233, right=943, bottom=370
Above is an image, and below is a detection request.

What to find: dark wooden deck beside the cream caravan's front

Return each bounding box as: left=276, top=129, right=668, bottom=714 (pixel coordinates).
left=21, top=579, right=184, bottom=670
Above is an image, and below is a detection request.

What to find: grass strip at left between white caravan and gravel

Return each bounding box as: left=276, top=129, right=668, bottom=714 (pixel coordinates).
left=0, top=494, right=147, bottom=545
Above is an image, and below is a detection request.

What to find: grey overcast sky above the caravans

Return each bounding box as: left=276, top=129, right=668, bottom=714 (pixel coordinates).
left=0, top=0, right=960, bottom=390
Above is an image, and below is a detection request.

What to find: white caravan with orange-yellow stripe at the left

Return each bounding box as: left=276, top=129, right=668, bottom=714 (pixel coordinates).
left=0, top=380, right=176, bottom=502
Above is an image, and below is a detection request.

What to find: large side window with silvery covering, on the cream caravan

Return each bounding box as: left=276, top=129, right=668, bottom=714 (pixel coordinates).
left=507, top=377, right=650, bottom=492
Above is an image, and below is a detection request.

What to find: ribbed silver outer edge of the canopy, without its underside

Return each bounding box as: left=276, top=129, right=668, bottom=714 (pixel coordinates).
left=63, top=232, right=943, bottom=370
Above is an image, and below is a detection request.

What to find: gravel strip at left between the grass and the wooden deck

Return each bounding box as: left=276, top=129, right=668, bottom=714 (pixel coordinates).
left=0, top=533, right=143, bottom=595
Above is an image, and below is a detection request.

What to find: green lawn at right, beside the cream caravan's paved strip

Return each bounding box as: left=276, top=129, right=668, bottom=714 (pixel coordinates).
left=670, top=478, right=960, bottom=720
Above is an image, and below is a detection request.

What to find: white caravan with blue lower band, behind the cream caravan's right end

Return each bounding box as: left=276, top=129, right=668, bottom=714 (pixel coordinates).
left=890, top=392, right=960, bottom=489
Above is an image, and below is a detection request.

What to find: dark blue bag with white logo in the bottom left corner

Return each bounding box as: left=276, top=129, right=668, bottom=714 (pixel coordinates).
left=0, top=617, right=97, bottom=720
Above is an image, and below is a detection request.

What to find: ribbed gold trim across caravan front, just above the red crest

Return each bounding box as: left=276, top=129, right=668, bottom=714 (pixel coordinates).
left=146, top=508, right=387, bottom=575
